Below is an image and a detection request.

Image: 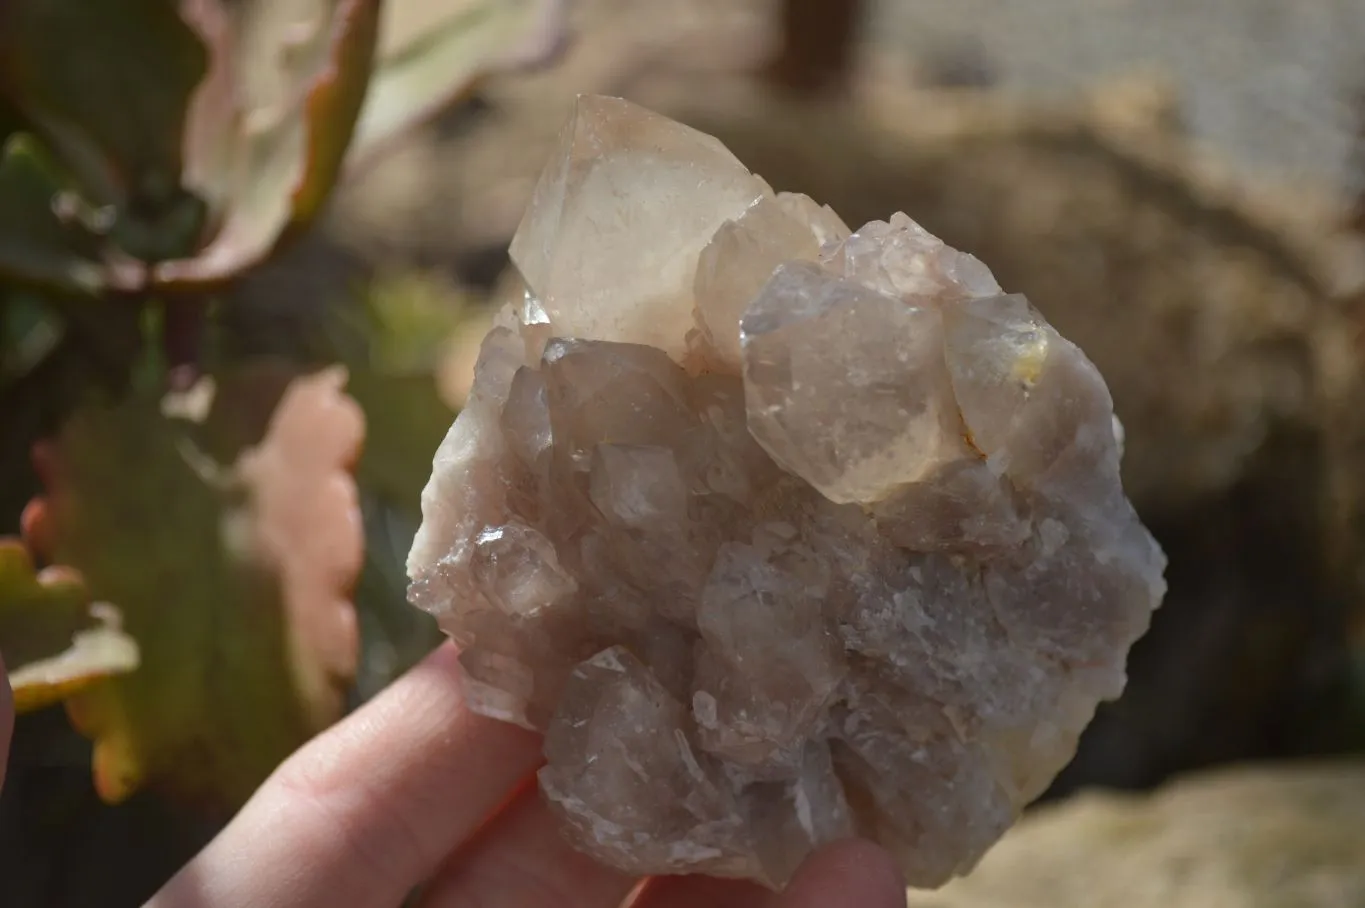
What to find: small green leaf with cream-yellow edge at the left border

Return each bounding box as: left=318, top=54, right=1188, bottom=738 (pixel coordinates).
left=0, top=539, right=138, bottom=713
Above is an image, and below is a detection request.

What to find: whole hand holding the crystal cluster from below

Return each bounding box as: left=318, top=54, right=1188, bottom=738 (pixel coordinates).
left=146, top=644, right=905, bottom=908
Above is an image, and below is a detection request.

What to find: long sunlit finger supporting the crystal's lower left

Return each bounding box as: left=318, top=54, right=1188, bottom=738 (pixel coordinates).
left=149, top=644, right=541, bottom=908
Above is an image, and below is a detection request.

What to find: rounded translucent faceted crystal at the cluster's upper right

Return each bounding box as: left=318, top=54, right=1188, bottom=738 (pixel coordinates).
left=740, top=262, right=966, bottom=504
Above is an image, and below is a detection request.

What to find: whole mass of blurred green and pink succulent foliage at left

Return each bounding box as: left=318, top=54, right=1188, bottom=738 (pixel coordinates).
left=0, top=0, right=562, bottom=905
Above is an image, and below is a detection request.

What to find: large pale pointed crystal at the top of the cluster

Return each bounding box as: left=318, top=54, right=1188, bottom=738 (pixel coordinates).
left=512, top=97, right=773, bottom=354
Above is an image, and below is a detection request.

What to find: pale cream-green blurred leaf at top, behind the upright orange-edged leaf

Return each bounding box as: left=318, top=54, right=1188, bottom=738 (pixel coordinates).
left=347, top=0, right=566, bottom=169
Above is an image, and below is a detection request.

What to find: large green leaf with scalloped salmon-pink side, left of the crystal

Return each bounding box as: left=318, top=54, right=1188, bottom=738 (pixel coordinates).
left=51, top=373, right=363, bottom=807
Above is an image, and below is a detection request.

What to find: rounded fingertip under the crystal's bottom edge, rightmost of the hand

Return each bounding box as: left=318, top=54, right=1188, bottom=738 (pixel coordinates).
left=777, top=838, right=905, bottom=908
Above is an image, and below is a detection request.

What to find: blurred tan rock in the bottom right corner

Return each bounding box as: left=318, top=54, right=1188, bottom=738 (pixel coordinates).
left=908, top=763, right=1365, bottom=908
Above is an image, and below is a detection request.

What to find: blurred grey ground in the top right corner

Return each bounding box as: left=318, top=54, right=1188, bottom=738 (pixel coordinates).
left=867, top=0, right=1365, bottom=187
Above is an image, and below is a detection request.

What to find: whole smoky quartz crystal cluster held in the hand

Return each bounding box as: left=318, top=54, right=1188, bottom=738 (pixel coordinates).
left=408, top=97, right=1164, bottom=886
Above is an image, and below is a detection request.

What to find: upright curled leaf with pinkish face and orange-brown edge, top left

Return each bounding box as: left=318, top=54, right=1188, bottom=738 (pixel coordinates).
left=153, top=0, right=379, bottom=287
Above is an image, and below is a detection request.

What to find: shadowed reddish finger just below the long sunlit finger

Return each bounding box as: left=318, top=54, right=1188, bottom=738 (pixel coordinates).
left=420, top=784, right=639, bottom=908
